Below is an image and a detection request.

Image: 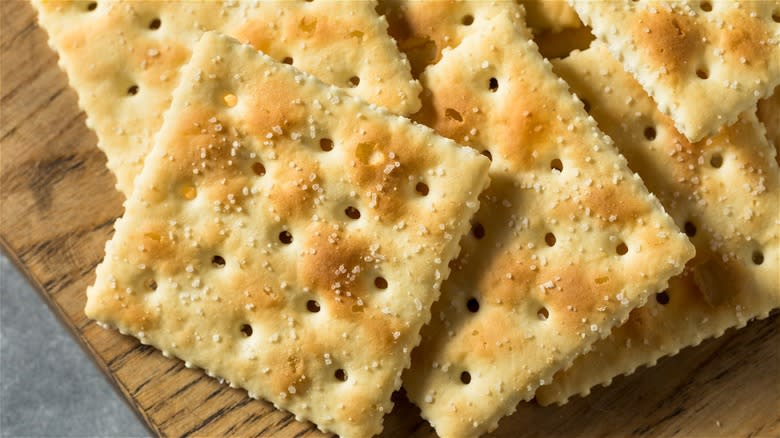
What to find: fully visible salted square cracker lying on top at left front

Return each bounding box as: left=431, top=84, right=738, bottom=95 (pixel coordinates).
left=86, top=32, right=489, bottom=436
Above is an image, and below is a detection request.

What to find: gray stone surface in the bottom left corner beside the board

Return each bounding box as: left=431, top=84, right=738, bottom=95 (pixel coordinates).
left=0, top=252, right=150, bottom=437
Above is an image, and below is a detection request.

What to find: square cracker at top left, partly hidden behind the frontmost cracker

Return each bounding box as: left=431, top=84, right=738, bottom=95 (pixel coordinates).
left=32, top=0, right=420, bottom=196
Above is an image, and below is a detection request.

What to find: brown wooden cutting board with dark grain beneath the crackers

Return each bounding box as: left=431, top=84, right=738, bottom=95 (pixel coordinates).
left=0, top=0, right=780, bottom=437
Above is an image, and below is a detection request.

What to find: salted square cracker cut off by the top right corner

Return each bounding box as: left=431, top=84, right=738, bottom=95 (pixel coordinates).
left=572, top=0, right=780, bottom=141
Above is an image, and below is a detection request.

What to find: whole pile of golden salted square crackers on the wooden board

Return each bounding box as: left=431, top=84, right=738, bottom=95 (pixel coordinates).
left=33, top=0, right=780, bottom=437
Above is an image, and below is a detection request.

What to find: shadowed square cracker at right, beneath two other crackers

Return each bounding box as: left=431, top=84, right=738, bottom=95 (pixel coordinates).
left=536, top=45, right=780, bottom=404
